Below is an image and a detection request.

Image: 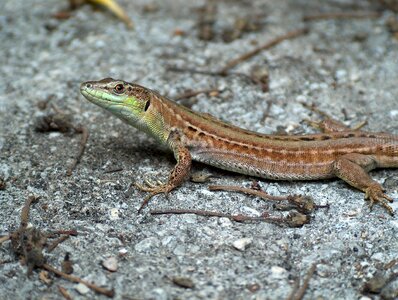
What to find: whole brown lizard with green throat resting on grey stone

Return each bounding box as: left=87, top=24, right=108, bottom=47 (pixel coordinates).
left=80, top=78, right=398, bottom=215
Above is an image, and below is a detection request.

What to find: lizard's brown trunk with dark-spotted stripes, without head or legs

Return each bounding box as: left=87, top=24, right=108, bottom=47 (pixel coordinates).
left=149, top=95, right=398, bottom=180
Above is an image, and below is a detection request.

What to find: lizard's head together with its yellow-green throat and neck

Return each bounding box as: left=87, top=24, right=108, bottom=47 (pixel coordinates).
left=80, top=78, right=167, bottom=142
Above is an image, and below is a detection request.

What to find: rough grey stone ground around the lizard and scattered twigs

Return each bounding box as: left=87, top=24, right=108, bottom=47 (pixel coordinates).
left=0, top=0, right=398, bottom=299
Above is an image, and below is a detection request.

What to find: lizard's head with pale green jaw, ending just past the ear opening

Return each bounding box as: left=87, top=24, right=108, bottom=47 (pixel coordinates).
left=80, top=78, right=151, bottom=127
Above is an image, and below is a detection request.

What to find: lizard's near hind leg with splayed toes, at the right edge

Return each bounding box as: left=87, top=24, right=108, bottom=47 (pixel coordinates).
left=333, top=153, right=393, bottom=215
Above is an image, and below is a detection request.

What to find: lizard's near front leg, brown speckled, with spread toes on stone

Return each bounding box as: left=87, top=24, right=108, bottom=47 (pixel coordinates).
left=135, top=131, right=192, bottom=212
